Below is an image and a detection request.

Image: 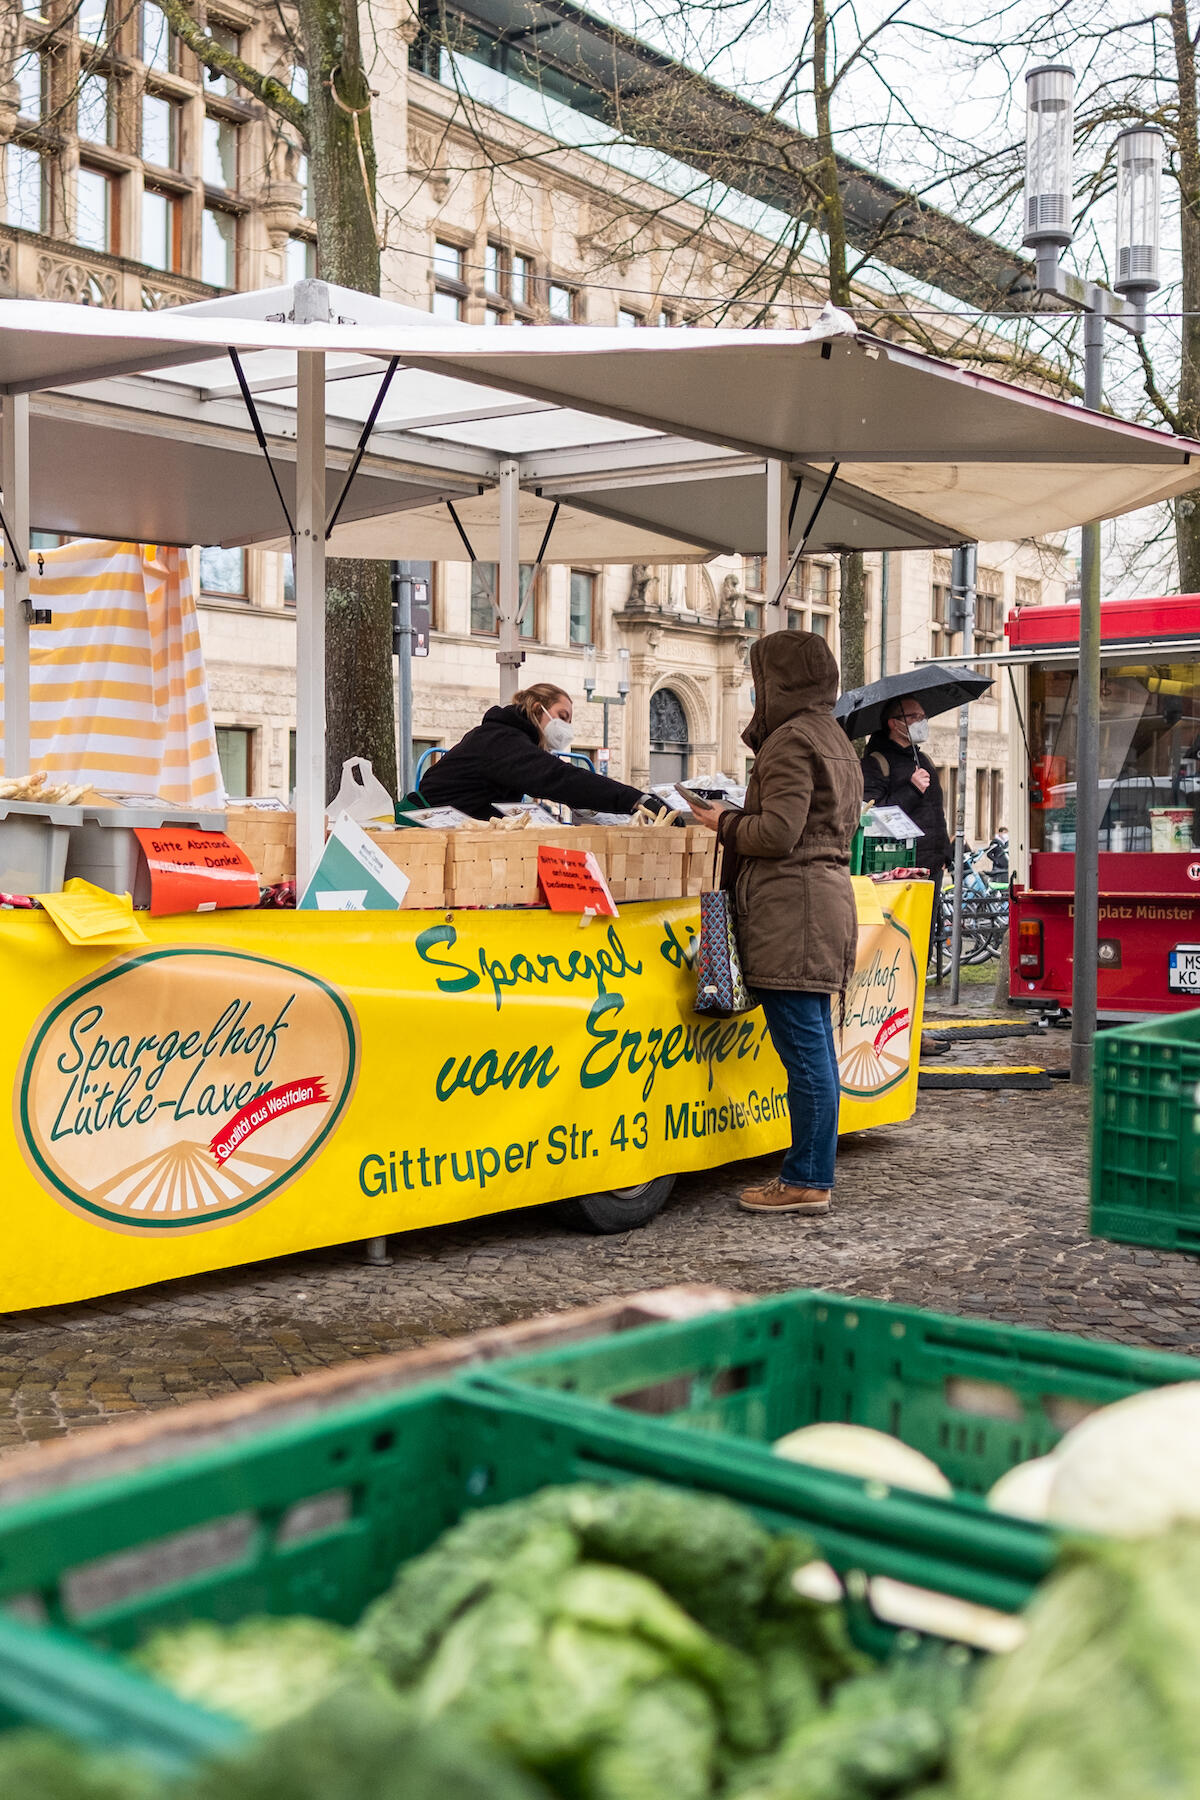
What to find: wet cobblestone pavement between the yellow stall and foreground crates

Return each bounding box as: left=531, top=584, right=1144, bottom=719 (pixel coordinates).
left=0, top=995, right=1200, bottom=1453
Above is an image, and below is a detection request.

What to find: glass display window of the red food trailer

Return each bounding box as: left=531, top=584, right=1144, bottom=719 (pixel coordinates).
left=1029, top=662, right=1200, bottom=851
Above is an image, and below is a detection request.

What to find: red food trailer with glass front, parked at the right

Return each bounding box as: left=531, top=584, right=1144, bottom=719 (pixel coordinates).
left=997, top=594, right=1200, bottom=1019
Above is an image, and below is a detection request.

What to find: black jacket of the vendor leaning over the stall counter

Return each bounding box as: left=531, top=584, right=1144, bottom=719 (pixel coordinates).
left=421, top=706, right=642, bottom=819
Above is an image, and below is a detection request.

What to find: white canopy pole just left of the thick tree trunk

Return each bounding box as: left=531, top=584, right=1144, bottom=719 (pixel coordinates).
left=295, top=349, right=326, bottom=895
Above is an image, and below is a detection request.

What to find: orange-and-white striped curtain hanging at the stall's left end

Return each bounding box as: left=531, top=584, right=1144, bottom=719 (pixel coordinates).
left=5, top=538, right=225, bottom=806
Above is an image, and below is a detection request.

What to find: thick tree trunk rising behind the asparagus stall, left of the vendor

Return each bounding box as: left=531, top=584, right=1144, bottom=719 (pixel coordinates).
left=299, top=0, right=398, bottom=797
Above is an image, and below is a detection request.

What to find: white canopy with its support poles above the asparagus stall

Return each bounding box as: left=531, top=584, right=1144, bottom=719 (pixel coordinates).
left=0, top=283, right=1200, bottom=878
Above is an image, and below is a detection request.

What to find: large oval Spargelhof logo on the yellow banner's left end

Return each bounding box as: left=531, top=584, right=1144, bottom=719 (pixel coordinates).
left=13, top=947, right=360, bottom=1233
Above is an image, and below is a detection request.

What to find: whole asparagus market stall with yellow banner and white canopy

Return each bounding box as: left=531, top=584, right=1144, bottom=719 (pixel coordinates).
left=0, top=283, right=1200, bottom=1309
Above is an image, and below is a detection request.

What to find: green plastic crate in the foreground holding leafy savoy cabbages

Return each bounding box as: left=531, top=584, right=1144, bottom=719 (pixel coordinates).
left=0, top=1375, right=1056, bottom=1751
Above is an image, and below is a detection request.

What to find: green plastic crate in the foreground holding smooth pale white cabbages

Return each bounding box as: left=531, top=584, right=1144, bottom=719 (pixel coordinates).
left=480, top=1291, right=1200, bottom=1512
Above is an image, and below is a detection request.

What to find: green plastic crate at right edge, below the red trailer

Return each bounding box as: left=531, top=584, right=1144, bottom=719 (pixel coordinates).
left=1092, top=1012, right=1200, bottom=1255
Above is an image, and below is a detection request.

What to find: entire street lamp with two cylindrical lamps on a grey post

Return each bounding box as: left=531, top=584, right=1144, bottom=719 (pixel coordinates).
left=1024, top=63, right=1162, bottom=1082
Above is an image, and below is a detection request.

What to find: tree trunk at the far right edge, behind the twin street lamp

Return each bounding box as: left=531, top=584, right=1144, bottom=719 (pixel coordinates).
left=1171, top=0, right=1200, bottom=594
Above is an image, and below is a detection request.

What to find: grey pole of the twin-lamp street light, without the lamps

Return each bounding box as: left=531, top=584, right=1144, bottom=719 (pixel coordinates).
left=1070, top=311, right=1105, bottom=1084
